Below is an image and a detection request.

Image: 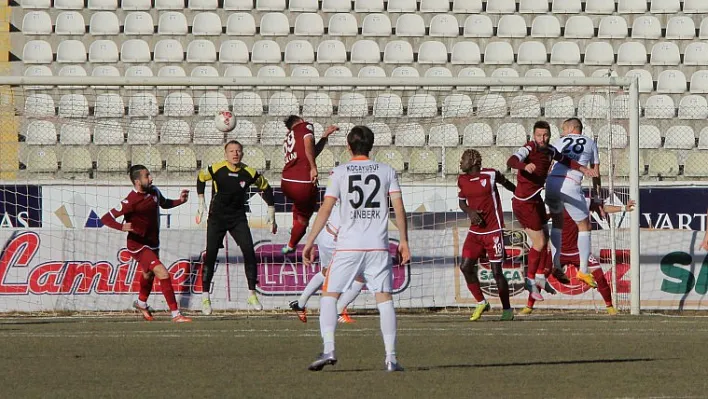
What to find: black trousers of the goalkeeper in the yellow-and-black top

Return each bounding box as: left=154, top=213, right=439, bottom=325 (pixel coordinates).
left=202, top=212, right=258, bottom=292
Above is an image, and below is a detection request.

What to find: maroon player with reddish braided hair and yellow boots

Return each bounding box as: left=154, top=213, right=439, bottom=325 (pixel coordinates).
left=457, top=150, right=516, bottom=321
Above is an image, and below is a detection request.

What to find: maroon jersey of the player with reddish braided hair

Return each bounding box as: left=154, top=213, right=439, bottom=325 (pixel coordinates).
left=457, top=168, right=504, bottom=234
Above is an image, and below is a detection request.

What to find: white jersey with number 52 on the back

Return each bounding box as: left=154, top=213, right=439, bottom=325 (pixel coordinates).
left=325, top=158, right=401, bottom=251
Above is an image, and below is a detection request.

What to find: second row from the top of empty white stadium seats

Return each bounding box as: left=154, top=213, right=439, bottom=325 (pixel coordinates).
left=22, top=11, right=708, bottom=40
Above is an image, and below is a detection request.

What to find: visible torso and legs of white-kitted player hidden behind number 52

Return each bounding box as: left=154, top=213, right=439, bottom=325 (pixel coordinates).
left=290, top=202, right=364, bottom=323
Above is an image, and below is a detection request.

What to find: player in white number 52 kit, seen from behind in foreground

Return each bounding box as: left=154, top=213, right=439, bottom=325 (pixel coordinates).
left=303, top=126, right=410, bottom=371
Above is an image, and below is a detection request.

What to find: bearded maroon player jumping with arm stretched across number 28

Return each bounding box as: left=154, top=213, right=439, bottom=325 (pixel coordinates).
left=506, top=121, right=597, bottom=301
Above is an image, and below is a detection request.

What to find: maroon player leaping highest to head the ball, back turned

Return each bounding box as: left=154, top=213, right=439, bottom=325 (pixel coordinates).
left=280, top=115, right=339, bottom=254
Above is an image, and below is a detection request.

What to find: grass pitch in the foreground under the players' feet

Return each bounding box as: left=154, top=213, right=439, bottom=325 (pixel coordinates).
left=0, top=312, right=708, bottom=399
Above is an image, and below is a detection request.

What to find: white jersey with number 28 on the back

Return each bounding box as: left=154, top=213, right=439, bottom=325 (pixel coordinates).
left=549, top=134, right=600, bottom=184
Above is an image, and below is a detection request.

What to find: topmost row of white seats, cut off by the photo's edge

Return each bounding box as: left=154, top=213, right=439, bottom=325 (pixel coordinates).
left=21, top=0, right=708, bottom=14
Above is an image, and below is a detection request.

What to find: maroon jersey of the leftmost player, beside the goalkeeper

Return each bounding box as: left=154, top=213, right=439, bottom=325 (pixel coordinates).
left=101, top=187, right=181, bottom=251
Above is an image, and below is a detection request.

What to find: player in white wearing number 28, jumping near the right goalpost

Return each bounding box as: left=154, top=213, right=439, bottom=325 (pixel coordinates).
left=546, top=118, right=600, bottom=288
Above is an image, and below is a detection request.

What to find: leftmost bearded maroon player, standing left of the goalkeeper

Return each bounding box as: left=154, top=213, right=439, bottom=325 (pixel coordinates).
left=101, top=165, right=192, bottom=323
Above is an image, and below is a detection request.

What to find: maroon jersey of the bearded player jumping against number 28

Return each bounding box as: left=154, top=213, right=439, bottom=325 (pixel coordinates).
left=507, top=141, right=577, bottom=200
